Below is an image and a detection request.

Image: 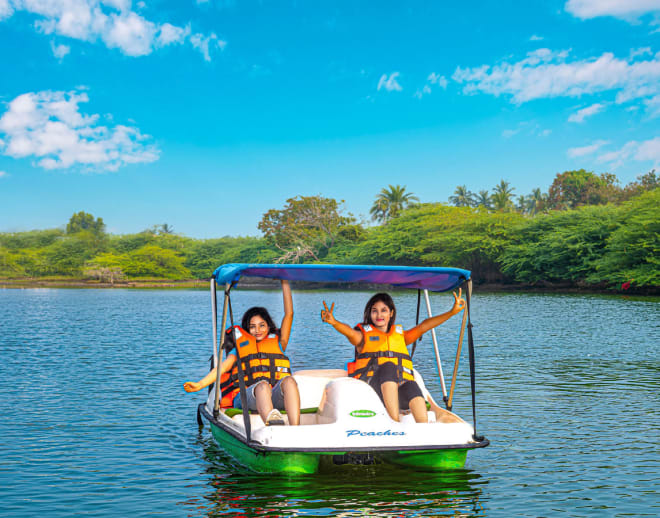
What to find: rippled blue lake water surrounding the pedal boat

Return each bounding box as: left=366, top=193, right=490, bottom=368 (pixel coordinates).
left=0, top=289, right=660, bottom=517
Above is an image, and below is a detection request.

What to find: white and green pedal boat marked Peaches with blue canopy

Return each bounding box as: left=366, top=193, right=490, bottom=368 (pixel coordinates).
left=197, top=264, right=489, bottom=474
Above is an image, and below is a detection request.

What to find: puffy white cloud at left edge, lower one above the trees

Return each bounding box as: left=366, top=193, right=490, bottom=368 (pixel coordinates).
left=0, top=91, right=159, bottom=171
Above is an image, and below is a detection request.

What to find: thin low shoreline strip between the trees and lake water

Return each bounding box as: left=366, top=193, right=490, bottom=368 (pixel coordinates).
left=0, top=277, right=660, bottom=296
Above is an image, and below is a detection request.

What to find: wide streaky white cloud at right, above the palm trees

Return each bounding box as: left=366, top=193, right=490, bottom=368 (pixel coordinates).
left=452, top=49, right=660, bottom=114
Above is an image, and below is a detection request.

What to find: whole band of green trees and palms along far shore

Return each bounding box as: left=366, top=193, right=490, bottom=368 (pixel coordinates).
left=0, top=169, right=660, bottom=288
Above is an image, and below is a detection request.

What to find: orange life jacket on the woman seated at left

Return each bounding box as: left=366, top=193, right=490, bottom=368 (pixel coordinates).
left=220, top=326, right=291, bottom=408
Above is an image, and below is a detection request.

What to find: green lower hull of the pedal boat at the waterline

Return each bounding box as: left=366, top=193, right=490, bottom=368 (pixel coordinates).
left=211, top=424, right=467, bottom=475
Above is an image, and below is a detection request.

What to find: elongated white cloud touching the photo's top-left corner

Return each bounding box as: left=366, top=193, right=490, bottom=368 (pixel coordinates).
left=0, top=0, right=226, bottom=60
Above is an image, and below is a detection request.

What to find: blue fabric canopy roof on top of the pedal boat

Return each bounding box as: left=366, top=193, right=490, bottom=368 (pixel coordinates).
left=213, top=263, right=470, bottom=291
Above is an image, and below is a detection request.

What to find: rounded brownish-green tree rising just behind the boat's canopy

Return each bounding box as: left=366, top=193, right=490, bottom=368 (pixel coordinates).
left=259, top=195, right=354, bottom=262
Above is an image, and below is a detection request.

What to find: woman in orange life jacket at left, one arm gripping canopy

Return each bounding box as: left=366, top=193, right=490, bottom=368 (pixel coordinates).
left=183, top=281, right=300, bottom=425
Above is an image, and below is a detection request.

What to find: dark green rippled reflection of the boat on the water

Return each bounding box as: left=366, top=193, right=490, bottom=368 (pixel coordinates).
left=187, top=436, right=488, bottom=517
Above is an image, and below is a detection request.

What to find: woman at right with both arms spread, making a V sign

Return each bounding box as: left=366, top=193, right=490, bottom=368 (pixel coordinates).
left=321, top=289, right=465, bottom=423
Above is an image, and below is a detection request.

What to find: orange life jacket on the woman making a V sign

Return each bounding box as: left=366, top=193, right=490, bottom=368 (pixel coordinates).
left=347, top=324, right=415, bottom=382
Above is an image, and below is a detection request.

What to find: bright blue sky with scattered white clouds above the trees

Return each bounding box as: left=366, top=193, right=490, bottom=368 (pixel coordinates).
left=0, top=0, right=660, bottom=238
